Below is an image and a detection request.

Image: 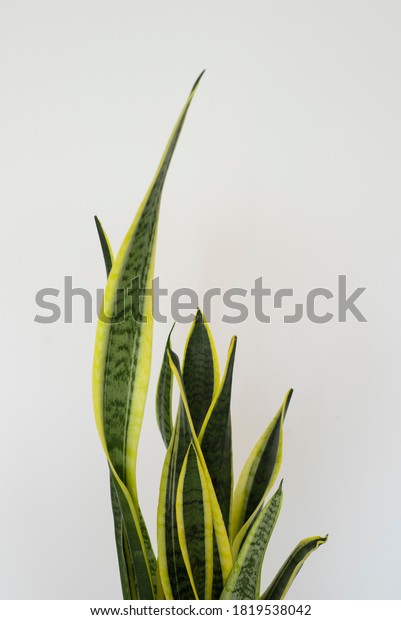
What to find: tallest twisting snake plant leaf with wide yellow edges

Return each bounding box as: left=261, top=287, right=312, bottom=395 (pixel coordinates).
left=93, top=74, right=203, bottom=598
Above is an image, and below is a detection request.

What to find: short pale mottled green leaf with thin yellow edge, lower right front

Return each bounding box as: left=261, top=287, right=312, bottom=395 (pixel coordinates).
left=221, top=485, right=282, bottom=600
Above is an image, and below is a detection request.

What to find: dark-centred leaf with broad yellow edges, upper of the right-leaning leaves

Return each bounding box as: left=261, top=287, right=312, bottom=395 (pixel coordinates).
left=232, top=390, right=292, bottom=556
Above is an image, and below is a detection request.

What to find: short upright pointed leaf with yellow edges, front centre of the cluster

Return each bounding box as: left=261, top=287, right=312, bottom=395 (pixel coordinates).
left=176, top=443, right=213, bottom=600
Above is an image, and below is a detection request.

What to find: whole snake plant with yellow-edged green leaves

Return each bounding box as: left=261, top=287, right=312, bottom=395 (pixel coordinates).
left=93, top=78, right=327, bottom=600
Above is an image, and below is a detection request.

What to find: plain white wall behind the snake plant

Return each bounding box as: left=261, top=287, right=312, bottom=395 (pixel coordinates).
left=0, top=0, right=401, bottom=599
